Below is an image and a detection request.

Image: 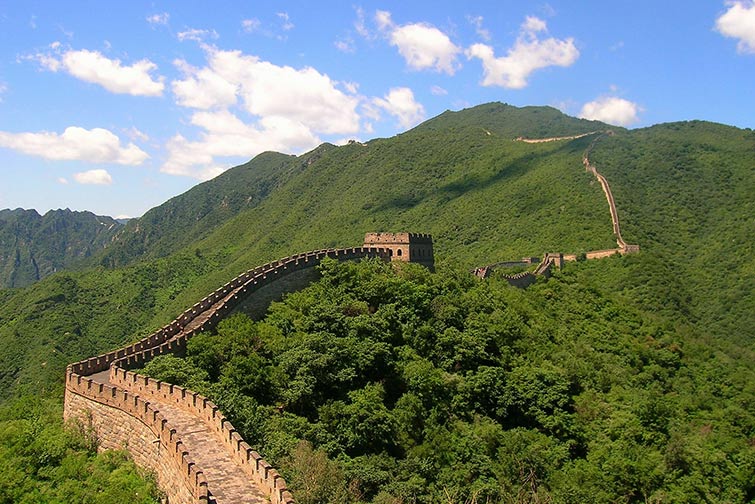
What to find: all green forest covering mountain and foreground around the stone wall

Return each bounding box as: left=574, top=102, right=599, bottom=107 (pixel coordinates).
left=0, top=104, right=755, bottom=503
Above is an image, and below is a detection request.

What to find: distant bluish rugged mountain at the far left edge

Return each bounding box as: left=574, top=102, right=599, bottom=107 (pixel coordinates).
left=0, top=208, right=121, bottom=287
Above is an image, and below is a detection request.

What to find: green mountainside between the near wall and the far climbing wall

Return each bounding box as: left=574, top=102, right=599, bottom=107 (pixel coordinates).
left=0, top=104, right=613, bottom=402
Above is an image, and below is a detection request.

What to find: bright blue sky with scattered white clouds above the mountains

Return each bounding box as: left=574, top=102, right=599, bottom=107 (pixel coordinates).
left=0, top=0, right=755, bottom=216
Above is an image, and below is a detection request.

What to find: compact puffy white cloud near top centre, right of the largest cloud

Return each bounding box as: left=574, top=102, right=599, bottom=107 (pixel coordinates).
left=375, top=11, right=461, bottom=75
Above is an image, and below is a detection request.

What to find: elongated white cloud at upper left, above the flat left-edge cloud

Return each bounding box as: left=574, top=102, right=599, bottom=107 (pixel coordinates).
left=29, top=48, right=165, bottom=96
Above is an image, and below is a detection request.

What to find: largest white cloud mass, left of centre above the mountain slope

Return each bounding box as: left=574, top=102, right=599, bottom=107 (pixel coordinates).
left=166, top=46, right=360, bottom=179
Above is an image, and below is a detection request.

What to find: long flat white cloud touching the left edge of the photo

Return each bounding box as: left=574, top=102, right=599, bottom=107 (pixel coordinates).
left=0, top=126, right=149, bottom=165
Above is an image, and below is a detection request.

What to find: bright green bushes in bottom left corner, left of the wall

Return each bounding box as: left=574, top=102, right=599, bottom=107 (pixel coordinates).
left=0, top=396, right=160, bottom=504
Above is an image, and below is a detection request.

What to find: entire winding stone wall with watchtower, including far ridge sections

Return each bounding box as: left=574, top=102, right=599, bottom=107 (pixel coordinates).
left=64, top=132, right=639, bottom=504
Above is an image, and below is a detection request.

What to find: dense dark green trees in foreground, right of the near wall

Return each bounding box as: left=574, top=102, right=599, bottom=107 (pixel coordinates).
left=143, top=258, right=755, bottom=503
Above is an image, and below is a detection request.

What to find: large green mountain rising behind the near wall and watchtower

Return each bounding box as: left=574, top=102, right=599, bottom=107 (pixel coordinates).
left=0, top=103, right=755, bottom=402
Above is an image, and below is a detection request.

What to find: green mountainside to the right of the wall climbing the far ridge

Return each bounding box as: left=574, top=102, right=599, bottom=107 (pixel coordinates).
left=592, top=121, right=755, bottom=345
